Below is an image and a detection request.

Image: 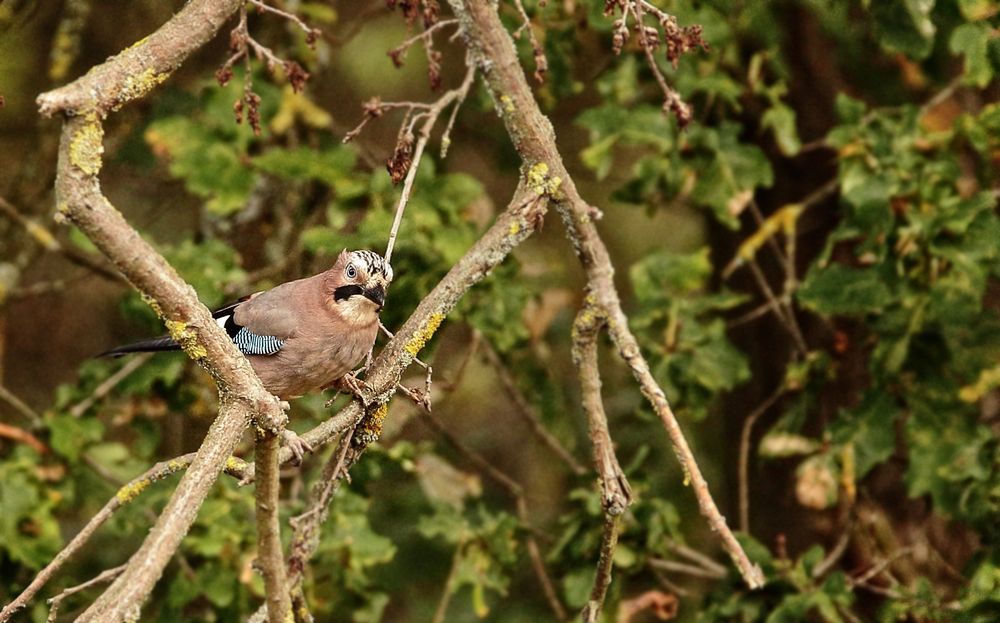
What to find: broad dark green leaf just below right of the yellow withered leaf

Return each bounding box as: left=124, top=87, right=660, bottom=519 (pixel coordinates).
left=797, top=264, right=892, bottom=315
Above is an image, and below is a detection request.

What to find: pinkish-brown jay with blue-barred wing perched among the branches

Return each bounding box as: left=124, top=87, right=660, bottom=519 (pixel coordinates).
left=98, top=249, right=393, bottom=459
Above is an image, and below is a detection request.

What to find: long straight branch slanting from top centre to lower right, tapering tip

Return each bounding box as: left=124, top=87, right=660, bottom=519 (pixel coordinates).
left=449, top=0, right=764, bottom=588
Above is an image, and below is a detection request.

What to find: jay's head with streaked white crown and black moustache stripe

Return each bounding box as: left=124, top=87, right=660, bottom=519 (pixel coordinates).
left=327, top=249, right=392, bottom=316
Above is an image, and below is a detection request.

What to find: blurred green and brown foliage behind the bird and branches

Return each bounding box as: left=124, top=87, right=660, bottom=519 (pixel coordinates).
left=0, top=0, right=1000, bottom=623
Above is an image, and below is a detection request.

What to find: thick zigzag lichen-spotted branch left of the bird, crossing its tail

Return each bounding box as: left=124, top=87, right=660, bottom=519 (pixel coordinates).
left=38, top=0, right=285, bottom=621
